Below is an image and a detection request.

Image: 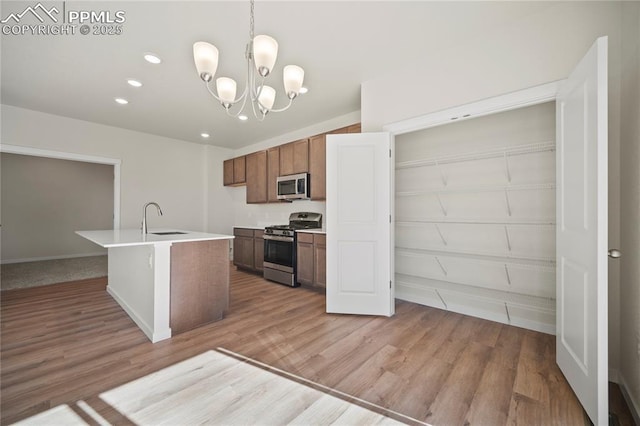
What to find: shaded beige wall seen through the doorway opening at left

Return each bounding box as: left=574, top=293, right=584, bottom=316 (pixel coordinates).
left=0, top=153, right=114, bottom=263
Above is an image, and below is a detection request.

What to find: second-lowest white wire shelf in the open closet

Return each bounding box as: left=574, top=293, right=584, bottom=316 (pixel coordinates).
left=395, top=246, right=556, bottom=271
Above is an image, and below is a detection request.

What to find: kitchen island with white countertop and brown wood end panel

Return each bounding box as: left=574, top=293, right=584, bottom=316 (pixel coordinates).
left=76, top=229, right=233, bottom=343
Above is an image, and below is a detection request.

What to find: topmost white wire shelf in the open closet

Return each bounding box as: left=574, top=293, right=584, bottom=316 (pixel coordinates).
left=396, top=141, right=556, bottom=169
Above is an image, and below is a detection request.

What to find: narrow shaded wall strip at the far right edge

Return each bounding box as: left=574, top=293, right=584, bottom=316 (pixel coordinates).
left=618, top=2, right=640, bottom=424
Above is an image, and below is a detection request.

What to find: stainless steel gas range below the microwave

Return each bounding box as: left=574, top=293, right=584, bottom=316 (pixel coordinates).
left=264, top=212, right=322, bottom=287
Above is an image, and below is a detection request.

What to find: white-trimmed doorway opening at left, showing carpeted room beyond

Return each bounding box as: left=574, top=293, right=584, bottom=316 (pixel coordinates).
left=0, top=145, right=120, bottom=290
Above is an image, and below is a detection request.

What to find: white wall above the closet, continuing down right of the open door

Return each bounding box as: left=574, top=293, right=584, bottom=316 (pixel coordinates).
left=361, top=2, right=637, bottom=392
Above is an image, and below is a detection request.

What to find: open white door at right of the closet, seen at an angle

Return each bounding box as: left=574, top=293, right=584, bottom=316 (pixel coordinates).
left=556, top=37, right=608, bottom=425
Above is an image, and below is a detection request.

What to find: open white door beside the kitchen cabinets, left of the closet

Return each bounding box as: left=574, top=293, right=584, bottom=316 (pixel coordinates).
left=326, top=133, right=395, bottom=316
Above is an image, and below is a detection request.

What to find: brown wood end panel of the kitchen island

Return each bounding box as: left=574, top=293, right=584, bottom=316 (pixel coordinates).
left=169, top=240, right=229, bottom=335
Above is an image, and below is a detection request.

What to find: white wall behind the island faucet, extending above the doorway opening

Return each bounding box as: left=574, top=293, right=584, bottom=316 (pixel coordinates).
left=1, top=105, right=207, bottom=235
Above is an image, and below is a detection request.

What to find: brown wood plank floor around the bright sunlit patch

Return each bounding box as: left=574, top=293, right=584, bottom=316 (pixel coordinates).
left=0, top=268, right=633, bottom=425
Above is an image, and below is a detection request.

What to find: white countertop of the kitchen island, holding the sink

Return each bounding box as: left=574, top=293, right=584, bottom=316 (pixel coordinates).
left=76, top=229, right=234, bottom=248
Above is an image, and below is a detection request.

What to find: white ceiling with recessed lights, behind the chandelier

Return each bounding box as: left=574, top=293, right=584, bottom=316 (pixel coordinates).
left=0, top=0, right=553, bottom=149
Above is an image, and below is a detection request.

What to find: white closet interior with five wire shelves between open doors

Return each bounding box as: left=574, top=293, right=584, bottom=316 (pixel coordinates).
left=395, top=102, right=556, bottom=333
